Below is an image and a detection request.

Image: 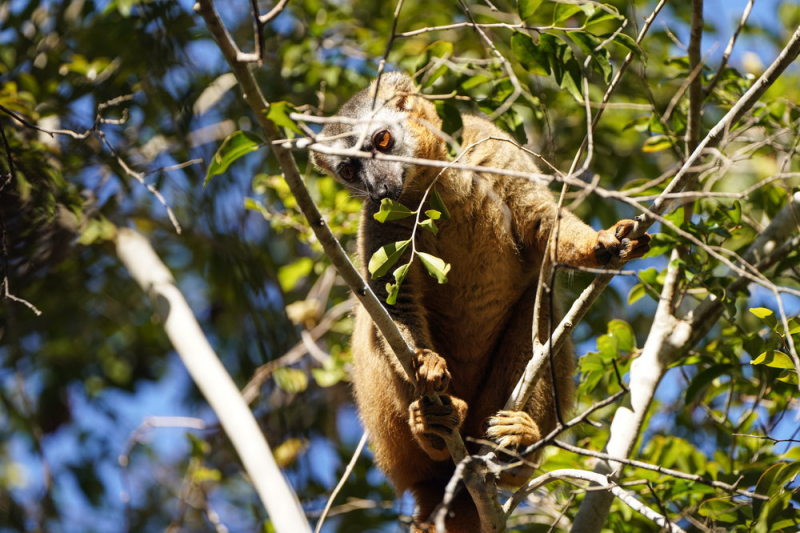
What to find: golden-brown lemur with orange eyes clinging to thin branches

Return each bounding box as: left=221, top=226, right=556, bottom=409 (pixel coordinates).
left=312, top=73, right=650, bottom=533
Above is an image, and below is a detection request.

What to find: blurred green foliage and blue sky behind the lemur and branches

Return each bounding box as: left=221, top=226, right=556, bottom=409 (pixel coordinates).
left=0, top=0, right=800, bottom=532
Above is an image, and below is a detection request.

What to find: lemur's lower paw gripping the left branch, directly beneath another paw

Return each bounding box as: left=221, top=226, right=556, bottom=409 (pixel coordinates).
left=408, top=394, right=467, bottom=461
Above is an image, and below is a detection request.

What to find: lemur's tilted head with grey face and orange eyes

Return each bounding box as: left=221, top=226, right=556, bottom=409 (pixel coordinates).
left=312, top=77, right=416, bottom=202
